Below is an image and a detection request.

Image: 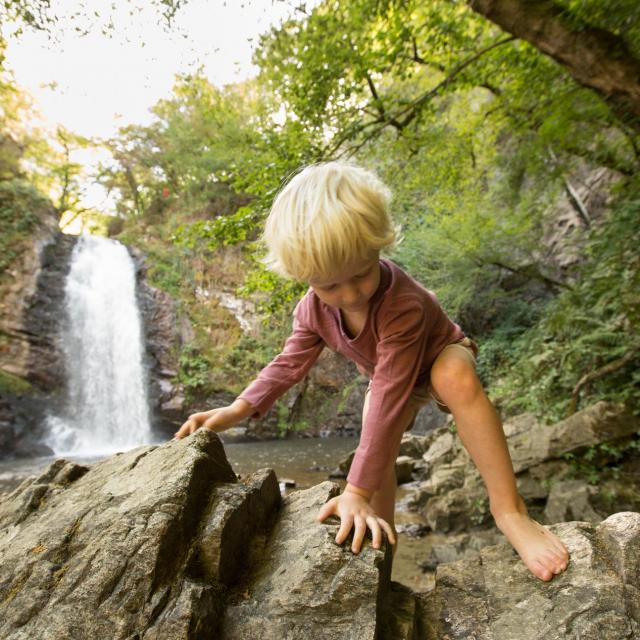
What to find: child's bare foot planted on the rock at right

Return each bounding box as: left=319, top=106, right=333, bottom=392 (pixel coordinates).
left=494, top=502, right=569, bottom=582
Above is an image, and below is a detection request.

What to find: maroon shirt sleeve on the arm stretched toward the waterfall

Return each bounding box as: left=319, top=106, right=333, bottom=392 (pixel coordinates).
left=238, top=299, right=324, bottom=418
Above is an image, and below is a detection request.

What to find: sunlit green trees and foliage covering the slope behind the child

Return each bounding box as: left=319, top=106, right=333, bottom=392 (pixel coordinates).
left=0, top=0, right=640, bottom=420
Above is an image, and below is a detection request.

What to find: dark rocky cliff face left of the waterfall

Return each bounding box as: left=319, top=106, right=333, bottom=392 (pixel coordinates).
left=0, top=211, right=75, bottom=458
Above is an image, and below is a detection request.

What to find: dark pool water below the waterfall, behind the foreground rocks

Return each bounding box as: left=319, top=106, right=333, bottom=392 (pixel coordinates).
left=0, top=438, right=357, bottom=493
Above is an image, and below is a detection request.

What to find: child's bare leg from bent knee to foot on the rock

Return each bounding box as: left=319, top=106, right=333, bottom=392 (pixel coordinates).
left=431, top=350, right=569, bottom=580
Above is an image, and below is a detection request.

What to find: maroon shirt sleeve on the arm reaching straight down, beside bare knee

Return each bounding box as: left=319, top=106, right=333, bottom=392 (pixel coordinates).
left=347, top=298, right=433, bottom=491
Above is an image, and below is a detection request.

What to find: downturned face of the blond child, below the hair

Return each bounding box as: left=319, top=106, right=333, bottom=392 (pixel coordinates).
left=309, top=253, right=380, bottom=313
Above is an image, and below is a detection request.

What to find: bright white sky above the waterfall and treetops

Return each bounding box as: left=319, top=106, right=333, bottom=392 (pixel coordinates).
left=3, top=0, right=304, bottom=212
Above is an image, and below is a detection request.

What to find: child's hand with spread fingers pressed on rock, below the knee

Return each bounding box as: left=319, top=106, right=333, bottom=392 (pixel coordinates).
left=317, top=489, right=396, bottom=553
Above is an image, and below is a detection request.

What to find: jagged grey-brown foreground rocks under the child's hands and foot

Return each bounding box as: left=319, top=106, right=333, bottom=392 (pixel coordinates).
left=0, top=430, right=640, bottom=640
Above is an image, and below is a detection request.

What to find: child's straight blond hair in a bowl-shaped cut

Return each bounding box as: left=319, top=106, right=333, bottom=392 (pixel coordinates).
left=263, top=162, right=398, bottom=281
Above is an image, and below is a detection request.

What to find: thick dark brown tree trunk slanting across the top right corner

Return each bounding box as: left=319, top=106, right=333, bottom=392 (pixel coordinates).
left=468, top=0, right=640, bottom=131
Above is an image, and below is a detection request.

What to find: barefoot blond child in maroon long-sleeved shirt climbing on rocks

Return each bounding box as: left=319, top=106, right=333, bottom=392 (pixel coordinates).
left=176, top=162, right=569, bottom=581
